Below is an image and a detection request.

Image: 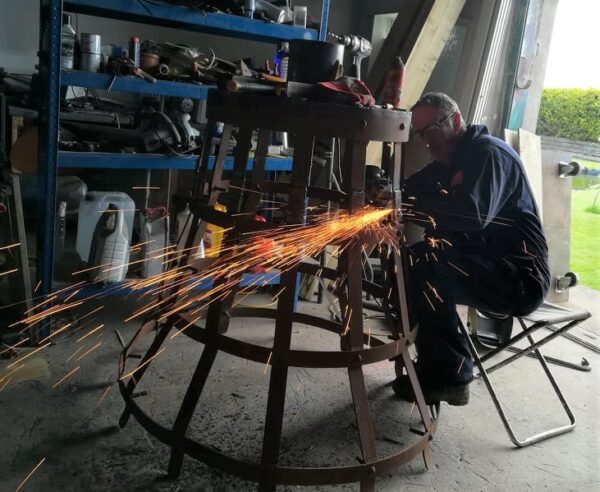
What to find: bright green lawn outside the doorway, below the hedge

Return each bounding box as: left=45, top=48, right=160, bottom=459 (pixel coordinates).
left=571, top=187, right=600, bottom=290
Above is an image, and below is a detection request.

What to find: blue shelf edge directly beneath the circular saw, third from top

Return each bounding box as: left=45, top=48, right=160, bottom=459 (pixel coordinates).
left=58, top=151, right=292, bottom=171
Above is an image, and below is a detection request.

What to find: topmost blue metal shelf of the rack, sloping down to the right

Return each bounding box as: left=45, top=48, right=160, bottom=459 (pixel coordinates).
left=64, top=0, right=319, bottom=42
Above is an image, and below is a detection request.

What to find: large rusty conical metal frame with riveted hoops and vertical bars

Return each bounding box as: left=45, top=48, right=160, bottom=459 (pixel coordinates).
left=119, top=93, right=439, bottom=491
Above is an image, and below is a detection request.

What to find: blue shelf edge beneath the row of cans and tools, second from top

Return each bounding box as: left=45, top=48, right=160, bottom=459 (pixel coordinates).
left=60, top=70, right=215, bottom=99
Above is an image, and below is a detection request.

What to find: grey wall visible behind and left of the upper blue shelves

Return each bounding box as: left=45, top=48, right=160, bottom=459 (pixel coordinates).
left=0, top=0, right=360, bottom=73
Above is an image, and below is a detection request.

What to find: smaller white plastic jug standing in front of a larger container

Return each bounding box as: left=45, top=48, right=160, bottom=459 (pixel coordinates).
left=94, top=204, right=130, bottom=282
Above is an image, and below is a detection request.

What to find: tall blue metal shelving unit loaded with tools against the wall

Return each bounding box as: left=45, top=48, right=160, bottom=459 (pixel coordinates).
left=36, top=0, right=329, bottom=324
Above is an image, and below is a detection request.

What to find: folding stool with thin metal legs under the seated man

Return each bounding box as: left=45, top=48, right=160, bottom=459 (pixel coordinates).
left=458, top=304, right=590, bottom=448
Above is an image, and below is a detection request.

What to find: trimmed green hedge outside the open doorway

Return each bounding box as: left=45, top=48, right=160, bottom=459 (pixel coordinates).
left=537, top=89, right=600, bottom=142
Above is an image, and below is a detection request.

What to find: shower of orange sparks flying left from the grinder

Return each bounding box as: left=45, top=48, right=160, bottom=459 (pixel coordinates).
left=9, top=208, right=406, bottom=392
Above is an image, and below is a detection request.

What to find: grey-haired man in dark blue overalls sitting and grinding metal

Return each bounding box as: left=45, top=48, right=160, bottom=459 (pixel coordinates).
left=393, top=93, right=550, bottom=405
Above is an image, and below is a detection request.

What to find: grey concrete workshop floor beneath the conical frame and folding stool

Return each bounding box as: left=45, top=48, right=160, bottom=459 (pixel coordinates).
left=0, top=288, right=600, bottom=491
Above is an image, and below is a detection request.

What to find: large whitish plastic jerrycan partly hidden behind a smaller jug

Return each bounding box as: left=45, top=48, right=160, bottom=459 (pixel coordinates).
left=75, top=191, right=135, bottom=262
